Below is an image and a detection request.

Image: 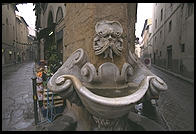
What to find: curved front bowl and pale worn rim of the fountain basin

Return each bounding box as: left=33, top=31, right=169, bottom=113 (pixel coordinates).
left=53, top=75, right=159, bottom=119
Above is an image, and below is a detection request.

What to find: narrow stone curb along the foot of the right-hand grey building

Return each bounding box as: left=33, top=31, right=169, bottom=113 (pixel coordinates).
left=152, top=64, right=194, bottom=84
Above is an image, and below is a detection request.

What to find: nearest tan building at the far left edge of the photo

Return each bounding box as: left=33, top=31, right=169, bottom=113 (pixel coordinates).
left=2, top=4, right=18, bottom=65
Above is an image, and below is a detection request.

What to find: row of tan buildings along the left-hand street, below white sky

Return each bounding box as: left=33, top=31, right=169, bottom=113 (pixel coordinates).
left=2, top=4, right=29, bottom=65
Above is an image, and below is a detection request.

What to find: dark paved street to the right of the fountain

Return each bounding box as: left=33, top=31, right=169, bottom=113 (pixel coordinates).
left=151, top=67, right=194, bottom=131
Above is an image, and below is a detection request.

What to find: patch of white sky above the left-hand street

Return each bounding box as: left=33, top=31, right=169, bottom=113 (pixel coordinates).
left=16, top=3, right=36, bottom=36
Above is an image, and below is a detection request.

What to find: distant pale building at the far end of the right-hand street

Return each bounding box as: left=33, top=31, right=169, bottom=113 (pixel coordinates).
left=141, top=18, right=152, bottom=58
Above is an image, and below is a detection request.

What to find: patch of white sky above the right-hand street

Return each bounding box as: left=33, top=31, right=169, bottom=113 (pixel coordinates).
left=135, top=3, right=153, bottom=42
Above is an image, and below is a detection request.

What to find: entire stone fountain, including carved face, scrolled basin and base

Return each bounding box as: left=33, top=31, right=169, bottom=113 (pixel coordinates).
left=48, top=20, right=167, bottom=130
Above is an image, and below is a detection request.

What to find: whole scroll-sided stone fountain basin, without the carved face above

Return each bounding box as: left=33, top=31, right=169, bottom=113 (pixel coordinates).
left=48, top=49, right=167, bottom=119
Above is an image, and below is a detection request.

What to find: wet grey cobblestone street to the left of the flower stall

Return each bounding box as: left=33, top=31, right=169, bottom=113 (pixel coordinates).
left=2, top=62, right=34, bottom=131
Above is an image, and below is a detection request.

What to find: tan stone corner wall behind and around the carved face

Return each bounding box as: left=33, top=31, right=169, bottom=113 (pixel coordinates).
left=63, top=3, right=136, bottom=69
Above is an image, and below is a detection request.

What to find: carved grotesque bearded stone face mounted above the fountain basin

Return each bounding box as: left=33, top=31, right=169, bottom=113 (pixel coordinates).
left=93, top=21, right=123, bottom=59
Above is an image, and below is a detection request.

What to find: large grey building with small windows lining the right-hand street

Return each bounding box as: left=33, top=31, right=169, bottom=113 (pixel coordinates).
left=149, top=3, right=194, bottom=79
